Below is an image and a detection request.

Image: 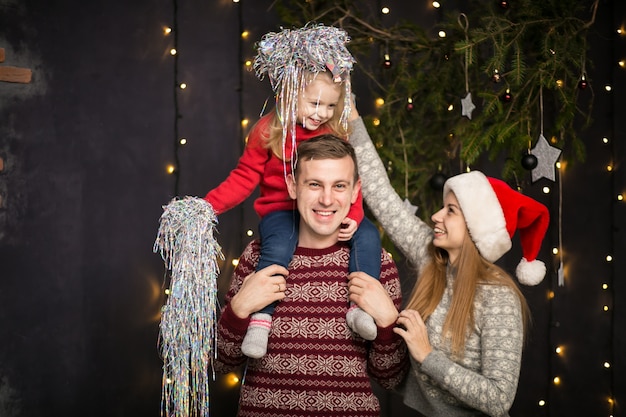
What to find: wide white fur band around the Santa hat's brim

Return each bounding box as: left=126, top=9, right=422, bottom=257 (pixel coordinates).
left=443, top=171, right=512, bottom=262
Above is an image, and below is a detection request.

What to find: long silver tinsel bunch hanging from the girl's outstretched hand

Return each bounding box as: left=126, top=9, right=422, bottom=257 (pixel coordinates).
left=153, top=197, right=224, bottom=417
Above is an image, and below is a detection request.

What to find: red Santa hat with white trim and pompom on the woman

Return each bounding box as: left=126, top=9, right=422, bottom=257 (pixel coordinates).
left=443, top=171, right=550, bottom=285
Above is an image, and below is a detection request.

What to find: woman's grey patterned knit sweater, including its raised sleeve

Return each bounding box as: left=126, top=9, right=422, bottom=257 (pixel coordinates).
left=350, top=118, right=523, bottom=417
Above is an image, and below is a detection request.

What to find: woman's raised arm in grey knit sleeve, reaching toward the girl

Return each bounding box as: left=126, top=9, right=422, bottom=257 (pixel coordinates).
left=349, top=117, right=432, bottom=270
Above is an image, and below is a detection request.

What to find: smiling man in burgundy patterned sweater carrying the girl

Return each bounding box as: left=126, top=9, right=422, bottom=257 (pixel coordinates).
left=215, top=135, right=407, bottom=417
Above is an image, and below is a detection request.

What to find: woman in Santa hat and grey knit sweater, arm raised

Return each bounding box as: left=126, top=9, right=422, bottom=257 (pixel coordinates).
left=349, top=111, right=549, bottom=417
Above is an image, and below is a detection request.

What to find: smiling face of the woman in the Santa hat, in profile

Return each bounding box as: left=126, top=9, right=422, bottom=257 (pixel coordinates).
left=431, top=192, right=468, bottom=263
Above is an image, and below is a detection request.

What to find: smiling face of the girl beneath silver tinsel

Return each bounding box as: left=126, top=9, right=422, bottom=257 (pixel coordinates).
left=298, top=73, right=342, bottom=130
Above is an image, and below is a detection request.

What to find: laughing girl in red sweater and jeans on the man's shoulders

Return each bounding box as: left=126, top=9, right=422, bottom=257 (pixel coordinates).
left=205, top=25, right=381, bottom=358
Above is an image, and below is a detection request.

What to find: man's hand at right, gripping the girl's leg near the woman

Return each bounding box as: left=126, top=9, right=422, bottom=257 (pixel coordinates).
left=348, top=272, right=398, bottom=327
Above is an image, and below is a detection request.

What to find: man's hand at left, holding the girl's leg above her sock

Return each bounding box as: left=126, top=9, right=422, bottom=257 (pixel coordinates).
left=230, top=265, right=289, bottom=318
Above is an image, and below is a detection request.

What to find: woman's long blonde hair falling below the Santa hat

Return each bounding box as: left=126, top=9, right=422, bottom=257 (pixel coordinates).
left=407, top=232, right=530, bottom=358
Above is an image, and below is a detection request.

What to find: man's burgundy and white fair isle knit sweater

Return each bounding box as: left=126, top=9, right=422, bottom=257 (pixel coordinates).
left=215, top=241, right=408, bottom=417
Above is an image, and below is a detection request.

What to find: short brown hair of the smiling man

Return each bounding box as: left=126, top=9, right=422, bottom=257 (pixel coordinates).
left=294, top=134, right=359, bottom=183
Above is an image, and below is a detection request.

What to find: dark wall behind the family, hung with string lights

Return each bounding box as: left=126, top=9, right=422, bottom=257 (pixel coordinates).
left=0, top=0, right=626, bottom=417
